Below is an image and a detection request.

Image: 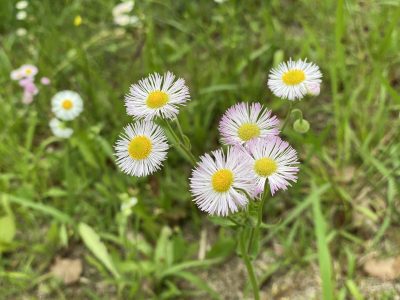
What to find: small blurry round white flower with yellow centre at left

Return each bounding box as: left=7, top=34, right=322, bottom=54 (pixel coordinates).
left=51, top=91, right=83, bottom=121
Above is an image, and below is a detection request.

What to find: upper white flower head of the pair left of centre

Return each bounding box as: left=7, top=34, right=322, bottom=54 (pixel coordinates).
left=125, top=72, right=190, bottom=120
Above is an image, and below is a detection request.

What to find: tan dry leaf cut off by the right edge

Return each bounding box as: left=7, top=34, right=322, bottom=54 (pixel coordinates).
left=364, top=256, right=400, bottom=280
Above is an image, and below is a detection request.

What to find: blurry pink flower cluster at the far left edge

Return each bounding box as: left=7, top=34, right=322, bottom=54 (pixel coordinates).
left=10, top=65, right=50, bottom=104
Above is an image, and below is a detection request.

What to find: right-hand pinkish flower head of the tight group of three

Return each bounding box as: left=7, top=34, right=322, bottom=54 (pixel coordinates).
left=247, top=136, right=299, bottom=196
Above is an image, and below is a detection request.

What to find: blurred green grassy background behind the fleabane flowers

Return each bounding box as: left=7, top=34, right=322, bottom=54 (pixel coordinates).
left=0, top=0, right=400, bottom=299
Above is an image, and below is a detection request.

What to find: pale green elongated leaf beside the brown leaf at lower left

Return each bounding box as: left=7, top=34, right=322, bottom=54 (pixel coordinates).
left=78, top=223, right=120, bottom=278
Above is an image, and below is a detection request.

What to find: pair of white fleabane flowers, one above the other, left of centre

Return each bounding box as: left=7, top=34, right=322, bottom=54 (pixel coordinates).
left=115, top=72, right=190, bottom=177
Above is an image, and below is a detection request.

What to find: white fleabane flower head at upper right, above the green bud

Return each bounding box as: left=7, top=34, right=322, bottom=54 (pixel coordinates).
left=268, top=59, right=322, bottom=100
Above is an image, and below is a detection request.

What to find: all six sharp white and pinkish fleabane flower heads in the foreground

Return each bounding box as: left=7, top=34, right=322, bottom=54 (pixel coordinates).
left=115, top=60, right=322, bottom=216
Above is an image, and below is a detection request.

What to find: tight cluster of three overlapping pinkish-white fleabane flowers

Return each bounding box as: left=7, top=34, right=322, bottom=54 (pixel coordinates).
left=190, top=103, right=299, bottom=216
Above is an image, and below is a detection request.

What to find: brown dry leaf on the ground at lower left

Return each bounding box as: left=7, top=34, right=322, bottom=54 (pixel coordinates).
left=50, top=257, right=82, bottom=284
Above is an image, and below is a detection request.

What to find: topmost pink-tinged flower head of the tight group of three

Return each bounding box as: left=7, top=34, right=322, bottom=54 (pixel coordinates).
left=219, top=102, right=279, bottom=145
